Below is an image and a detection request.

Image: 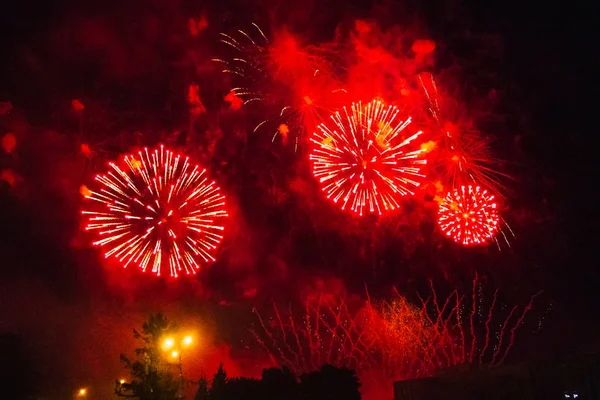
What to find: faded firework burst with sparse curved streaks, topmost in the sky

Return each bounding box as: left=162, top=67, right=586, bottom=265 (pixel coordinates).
left=213, top=24, right=346, bottom=150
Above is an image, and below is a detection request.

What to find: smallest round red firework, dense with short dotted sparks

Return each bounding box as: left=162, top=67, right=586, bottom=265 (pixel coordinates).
left=438, top=186, right=500, bottom=246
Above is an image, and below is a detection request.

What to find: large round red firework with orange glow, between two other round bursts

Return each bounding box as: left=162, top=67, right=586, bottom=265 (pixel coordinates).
left=310, top=100, right=426, bottom=215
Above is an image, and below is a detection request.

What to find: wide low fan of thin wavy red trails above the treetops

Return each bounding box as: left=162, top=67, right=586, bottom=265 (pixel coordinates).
left=251, top=277, right=539, bottom=381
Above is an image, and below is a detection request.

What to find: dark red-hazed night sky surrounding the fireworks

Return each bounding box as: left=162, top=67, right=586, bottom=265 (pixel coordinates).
left=0, top=0, right=600, bottom=397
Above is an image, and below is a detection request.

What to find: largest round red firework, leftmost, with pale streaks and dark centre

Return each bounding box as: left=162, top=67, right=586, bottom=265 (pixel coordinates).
left=82, top=146, right=227, bottom=277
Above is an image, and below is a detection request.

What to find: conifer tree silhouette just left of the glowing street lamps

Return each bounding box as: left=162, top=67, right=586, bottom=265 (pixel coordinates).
left=115, top=314, right=178, bottom=400
